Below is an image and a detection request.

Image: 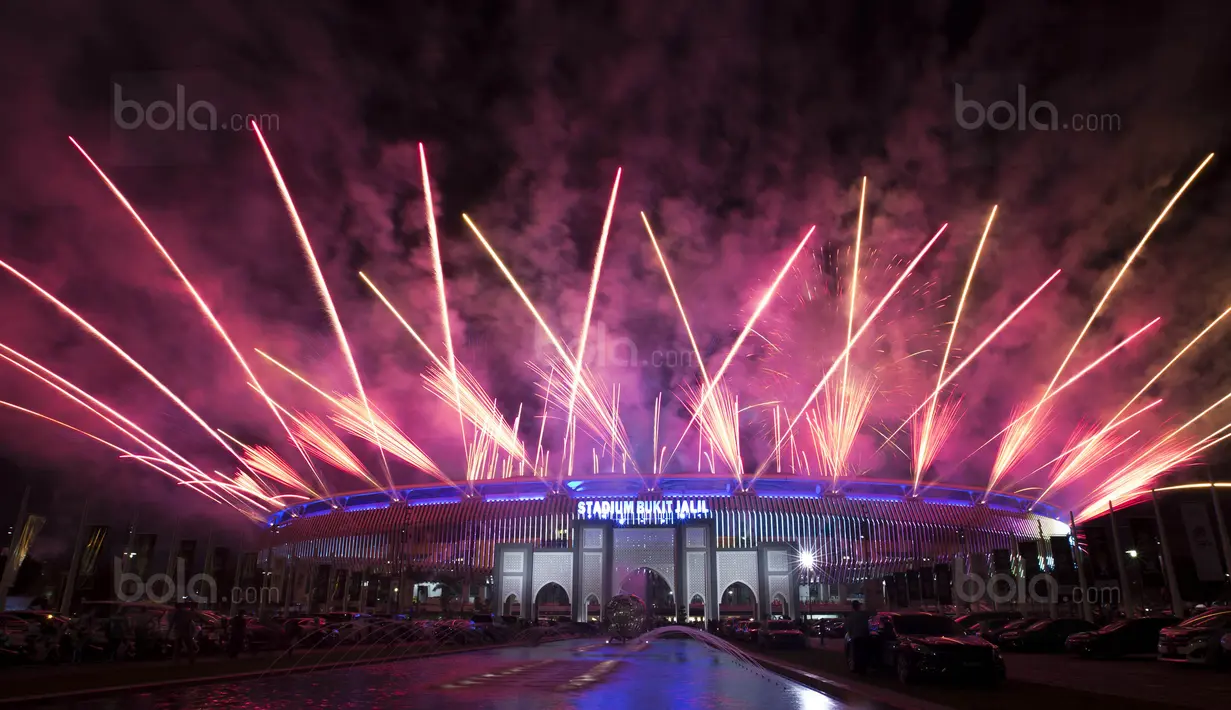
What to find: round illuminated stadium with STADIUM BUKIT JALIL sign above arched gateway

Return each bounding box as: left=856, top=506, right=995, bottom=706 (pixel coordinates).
left=262, top=474, right=1072, bottom=620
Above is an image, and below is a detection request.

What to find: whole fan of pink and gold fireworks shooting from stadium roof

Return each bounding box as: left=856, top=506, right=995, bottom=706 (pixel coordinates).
left=0, top=126, right=1231, bottom=519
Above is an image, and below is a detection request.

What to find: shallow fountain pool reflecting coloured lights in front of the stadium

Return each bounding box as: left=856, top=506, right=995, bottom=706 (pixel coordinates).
left=31, top=640, right=849, bottom=710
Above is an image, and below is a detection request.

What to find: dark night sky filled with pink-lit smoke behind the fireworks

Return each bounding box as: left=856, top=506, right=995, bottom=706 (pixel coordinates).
left=0, top=0, right=1231, bottom=553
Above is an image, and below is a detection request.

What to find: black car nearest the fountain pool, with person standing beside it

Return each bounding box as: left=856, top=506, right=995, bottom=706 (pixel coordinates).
left=846, top=612, right=1004, bottom=684
